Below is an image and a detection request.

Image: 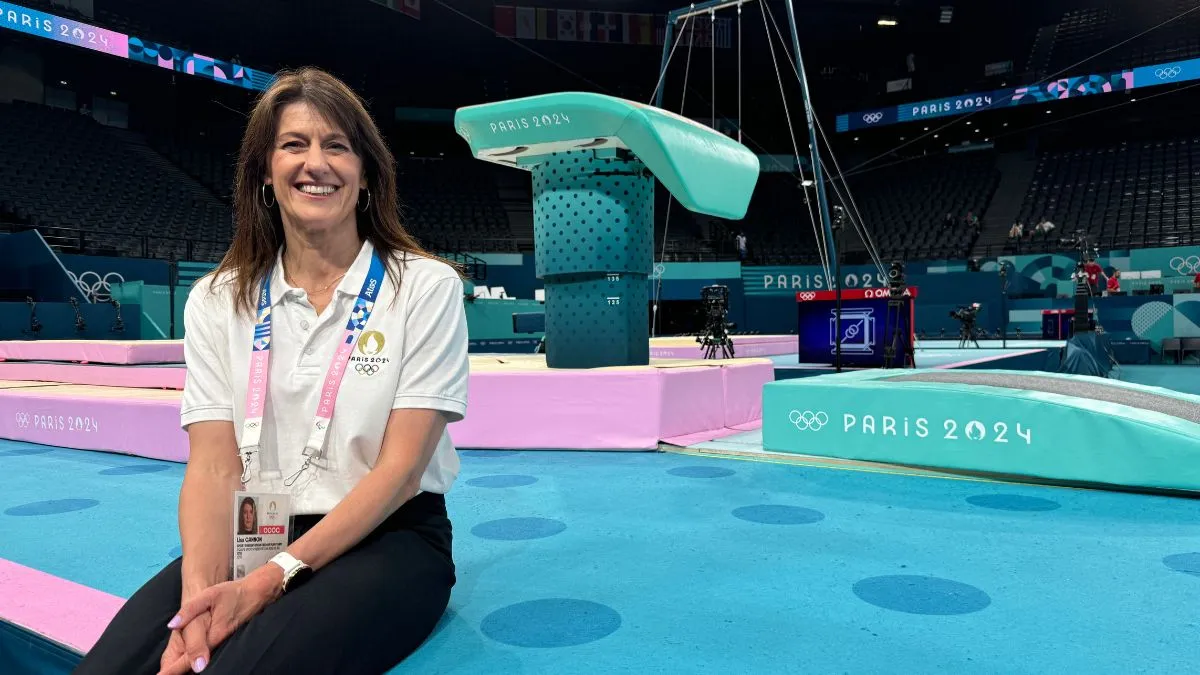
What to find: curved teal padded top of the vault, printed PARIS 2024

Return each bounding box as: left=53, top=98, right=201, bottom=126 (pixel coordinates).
left=455, top=91, right=758, bottom=220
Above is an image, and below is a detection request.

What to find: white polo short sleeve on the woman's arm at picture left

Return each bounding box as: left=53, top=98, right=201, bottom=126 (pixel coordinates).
left=180, top=280, right=234, bottom=429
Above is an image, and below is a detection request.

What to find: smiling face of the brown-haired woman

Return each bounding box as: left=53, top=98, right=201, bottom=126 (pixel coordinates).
left=266, top=102, right=366, bottom=232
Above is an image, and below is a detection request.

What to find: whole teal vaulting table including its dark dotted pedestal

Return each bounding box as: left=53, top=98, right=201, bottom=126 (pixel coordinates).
left=455, top=92, right=758, bottom=368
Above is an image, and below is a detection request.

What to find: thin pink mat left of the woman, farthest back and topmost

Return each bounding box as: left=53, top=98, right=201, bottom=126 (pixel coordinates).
left=0, top=340, right=184, bottom=365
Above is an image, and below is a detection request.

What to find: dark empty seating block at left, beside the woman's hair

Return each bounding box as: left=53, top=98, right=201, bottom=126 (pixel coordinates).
left=0, top=102, right=230, bottom=261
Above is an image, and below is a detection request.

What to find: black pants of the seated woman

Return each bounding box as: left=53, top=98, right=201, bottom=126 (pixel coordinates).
left=76, top=492, right=455, bottom=675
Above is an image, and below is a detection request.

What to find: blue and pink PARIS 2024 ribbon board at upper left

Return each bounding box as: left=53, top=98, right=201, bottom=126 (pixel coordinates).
left=0, top=2, right=275, bottom=91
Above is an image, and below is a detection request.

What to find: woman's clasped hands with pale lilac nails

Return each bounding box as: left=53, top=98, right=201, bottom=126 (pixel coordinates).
left=158, top=565, right=283, bottom=675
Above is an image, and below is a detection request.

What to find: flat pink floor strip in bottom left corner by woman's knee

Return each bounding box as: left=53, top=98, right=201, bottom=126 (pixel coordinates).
left=0, top=558, right=125, bottom=653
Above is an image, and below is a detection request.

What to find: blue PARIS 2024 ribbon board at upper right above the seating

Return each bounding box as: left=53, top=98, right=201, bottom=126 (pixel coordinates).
left=836, top=54, right=1200, bottom=132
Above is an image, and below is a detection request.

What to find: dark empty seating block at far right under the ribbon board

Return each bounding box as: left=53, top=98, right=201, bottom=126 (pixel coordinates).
left=1018, top=137, right=1200, bottom=249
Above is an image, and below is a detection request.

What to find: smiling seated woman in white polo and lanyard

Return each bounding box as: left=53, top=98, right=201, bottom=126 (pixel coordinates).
left=78, top=70, right=468, bottom=675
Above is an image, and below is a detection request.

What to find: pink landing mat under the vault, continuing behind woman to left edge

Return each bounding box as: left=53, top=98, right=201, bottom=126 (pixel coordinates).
left=0, top=359, right=774, bottom=454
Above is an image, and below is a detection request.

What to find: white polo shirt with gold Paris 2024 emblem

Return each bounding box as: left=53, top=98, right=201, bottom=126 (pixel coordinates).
left=180, top=241, right=469, bottom=514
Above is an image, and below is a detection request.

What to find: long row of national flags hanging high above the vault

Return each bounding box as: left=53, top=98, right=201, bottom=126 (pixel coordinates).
left=494, top=5, right=733, bottom=49
